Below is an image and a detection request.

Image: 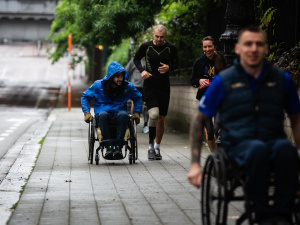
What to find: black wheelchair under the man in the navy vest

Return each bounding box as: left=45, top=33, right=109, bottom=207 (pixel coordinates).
left=201, top=147, right=300, bottom=225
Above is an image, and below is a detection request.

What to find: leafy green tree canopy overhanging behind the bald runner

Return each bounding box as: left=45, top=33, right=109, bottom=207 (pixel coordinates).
left=49, top=0, right=226, bottom=78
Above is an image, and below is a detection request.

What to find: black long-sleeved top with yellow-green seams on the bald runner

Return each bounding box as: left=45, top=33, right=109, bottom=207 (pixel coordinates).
left=134, top=41, right=178, bottom=90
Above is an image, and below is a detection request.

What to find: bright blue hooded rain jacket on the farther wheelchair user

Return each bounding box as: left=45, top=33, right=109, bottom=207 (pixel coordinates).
left=81, top=61, right=142, bottom=115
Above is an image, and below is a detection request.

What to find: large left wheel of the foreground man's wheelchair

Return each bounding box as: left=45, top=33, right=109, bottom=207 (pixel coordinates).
left=201, top=155, right=228, bottom=225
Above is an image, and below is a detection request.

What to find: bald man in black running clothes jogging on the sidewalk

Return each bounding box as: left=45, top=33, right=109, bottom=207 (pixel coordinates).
left=134, top=25, right=178, bottom=160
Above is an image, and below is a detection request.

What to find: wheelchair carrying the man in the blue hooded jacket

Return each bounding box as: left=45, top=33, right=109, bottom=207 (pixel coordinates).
left=88, top=114, right=138, bottom=165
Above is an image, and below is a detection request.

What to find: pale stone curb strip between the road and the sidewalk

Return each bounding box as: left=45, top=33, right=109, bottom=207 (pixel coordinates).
left=0, top=113, right=52, bottom=224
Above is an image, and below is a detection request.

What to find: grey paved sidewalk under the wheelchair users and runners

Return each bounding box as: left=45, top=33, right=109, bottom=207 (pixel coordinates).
left=8, top=108, right=207, bottom=225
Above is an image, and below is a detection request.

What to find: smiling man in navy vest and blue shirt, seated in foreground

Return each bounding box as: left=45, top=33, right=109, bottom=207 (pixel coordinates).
left=188, top=27, right=300, bottom=225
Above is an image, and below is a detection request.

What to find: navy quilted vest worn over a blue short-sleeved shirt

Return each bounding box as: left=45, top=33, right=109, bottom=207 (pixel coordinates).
left=220, top=61, right=285, bottom=147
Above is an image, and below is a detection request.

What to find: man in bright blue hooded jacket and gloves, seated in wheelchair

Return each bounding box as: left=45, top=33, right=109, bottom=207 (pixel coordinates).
left=81, top=61, right=142, bottom=159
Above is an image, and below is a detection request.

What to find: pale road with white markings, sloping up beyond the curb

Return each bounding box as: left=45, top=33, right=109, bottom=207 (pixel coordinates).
left=0, top=43, right=68, bottom=158
